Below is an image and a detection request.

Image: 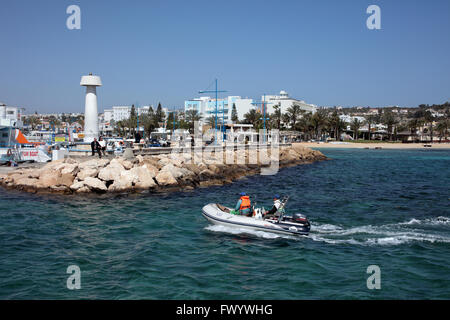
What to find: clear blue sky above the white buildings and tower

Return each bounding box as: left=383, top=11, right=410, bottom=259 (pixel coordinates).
left=0, top=0, right=450, bottom=113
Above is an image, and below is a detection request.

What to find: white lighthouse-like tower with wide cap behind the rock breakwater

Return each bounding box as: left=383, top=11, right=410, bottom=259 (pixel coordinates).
left=80, top=73, right=102, bottom=142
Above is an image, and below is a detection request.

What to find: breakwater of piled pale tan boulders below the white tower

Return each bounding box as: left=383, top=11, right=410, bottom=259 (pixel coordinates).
left=0, top=145, right=327, bottom=194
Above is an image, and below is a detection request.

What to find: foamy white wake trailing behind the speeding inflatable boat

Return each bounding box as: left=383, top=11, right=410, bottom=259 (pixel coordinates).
left=205, top=217, right=450, bottom=246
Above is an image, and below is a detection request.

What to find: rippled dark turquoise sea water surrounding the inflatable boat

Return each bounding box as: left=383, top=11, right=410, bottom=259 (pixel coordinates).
left=0, top=149, right=450, bottom=299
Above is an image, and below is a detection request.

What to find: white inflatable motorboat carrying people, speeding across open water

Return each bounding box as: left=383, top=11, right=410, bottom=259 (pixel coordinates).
left=202, top=203, right=311, bottom=236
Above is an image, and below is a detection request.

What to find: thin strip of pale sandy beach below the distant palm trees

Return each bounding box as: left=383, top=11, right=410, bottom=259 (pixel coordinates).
left=293, top=142, right=450, bottom=149
